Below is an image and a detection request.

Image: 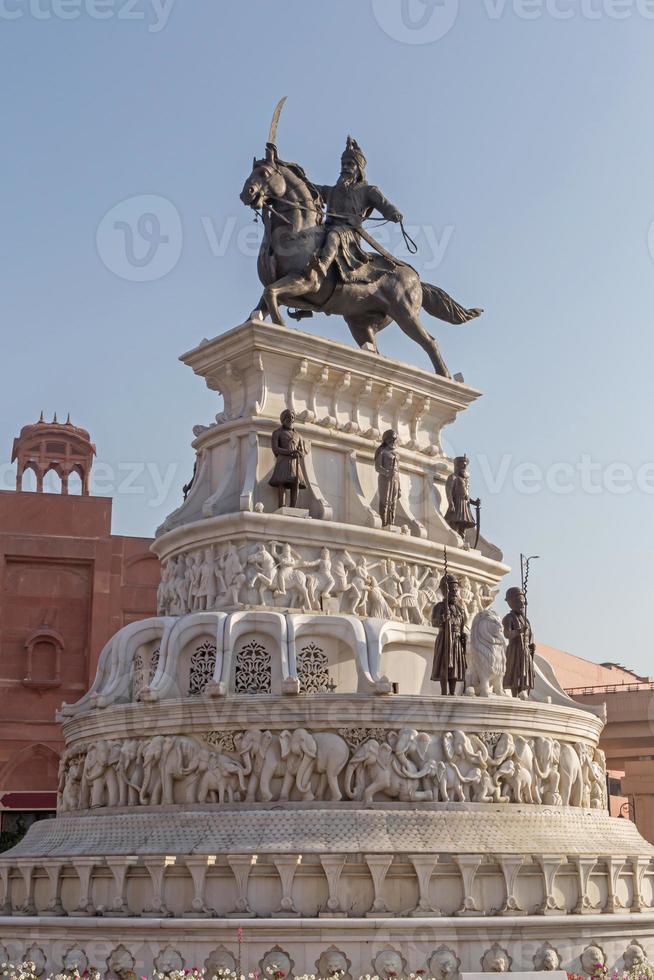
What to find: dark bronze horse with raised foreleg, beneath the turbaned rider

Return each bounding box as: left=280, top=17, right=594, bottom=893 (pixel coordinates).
left=240, top=107, right=483, bottom=377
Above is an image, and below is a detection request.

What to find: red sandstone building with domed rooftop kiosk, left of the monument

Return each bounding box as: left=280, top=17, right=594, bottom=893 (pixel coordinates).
left=0, top=417, right=159, bottom=840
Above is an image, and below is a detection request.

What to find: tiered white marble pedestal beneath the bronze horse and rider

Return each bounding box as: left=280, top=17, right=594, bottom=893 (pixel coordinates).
left=0, top=113, right=654, bottom=980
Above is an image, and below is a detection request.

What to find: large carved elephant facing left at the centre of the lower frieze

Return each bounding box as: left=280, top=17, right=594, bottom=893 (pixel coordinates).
left=279, top=728, right=350, bottom=801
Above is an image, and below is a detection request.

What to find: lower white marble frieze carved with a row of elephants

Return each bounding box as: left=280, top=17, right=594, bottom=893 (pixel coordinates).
left=59, top=727, right=605, bottom=812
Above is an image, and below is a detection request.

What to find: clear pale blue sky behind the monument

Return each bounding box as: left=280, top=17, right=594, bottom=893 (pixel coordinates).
left=0, top=0, right=654, bottom=674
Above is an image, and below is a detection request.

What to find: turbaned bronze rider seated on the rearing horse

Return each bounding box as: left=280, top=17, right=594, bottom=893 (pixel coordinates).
left=309, top=136, right=402, bottom=282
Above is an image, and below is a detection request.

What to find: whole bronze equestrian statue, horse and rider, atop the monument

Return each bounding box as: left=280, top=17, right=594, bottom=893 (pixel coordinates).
left=241, top=99, right=483, bottom=377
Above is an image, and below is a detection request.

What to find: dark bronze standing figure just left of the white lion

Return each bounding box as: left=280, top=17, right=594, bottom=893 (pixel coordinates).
left=431, top=572, right=468, bottom=694
